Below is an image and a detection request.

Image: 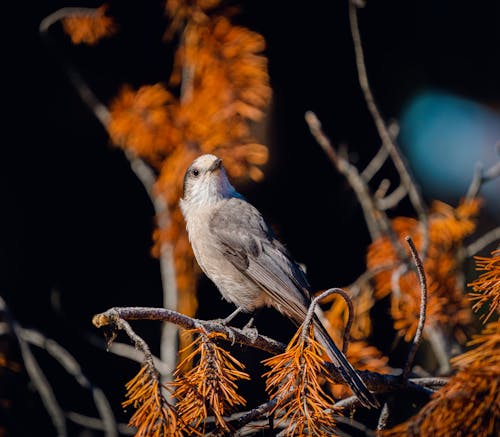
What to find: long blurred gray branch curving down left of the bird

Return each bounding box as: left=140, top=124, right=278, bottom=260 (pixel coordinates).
left=39, top=8, right=178, bottom=379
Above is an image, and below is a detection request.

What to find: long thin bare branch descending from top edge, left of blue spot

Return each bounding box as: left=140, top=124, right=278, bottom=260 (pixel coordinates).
left=348, top=0, right=429, bottom=247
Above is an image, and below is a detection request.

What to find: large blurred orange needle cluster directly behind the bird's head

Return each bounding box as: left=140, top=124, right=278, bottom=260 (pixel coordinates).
left=105, top=0, right=271, bottom=338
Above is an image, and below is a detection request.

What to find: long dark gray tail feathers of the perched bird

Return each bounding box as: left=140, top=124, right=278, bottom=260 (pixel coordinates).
left=314, top=316, right=380, bottom=408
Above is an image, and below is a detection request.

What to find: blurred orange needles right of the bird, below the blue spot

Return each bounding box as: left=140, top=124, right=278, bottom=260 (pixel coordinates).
left=367, top=199, right=480, bottom=341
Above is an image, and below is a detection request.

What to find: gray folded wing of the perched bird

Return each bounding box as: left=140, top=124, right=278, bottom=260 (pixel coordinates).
left=209, top=198, right=310, bottom=323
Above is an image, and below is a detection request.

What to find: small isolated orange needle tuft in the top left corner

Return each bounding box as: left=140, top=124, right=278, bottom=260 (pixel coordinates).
left=62, top=4, right=116, bottom=45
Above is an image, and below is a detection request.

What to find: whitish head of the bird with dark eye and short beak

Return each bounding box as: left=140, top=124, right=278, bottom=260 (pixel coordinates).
left=181, top=154, right=239, bottom=207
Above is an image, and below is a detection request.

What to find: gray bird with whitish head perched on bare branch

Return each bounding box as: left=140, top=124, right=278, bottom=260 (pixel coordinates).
left=180, top=154, right=378, bottom=407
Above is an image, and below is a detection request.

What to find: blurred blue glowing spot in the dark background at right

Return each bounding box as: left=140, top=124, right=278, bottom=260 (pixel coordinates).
left=400, top=90, right=500, bottom=217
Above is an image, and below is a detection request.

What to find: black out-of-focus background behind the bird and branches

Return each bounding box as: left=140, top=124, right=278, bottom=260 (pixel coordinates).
left=0, top=0, right=500, bottom=435
